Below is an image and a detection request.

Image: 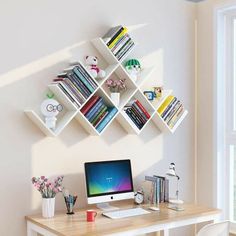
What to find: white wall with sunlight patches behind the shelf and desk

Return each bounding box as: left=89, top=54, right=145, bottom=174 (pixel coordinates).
left=0, top=0, right=195, bottom=236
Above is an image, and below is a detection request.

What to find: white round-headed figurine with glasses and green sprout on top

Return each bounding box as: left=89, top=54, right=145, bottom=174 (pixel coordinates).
left=41, top=94, right=63, bottom=130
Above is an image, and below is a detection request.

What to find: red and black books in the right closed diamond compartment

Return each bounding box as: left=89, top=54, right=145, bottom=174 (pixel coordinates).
left=124, top=100, right=150, bottom=129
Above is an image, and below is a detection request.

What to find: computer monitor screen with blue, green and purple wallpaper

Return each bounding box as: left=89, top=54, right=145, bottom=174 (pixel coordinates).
left=85, top=160, right=133, bottom=197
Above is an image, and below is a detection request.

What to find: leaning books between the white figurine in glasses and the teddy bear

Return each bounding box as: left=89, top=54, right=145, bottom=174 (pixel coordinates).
left=53, top=64, right=98, bottom=108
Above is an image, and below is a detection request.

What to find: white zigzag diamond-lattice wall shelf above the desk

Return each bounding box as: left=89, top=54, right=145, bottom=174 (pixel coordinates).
left=24, top=25, right=188, bottom=137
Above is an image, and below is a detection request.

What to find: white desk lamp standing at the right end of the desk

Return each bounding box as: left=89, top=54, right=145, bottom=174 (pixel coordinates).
left=166, top=163, right=184, bottom=211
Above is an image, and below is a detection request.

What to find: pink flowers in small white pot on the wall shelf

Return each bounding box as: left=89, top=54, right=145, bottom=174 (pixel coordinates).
left=106, top=79, right=127, bottom=106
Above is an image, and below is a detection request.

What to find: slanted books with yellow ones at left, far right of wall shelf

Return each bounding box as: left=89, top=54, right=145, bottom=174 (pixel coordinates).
left=157, top=96, right=184, bottom=129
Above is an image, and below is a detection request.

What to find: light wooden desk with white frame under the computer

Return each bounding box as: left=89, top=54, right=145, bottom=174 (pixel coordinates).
left=26, top=201, right=221, bottom=236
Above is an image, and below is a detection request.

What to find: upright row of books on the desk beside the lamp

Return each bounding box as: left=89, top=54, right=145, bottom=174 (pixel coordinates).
left=145, top=175, right=169, bottom=204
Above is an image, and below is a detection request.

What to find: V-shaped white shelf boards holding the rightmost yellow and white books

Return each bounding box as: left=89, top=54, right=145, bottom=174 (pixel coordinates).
left=152, top=110, right=188, bottom=134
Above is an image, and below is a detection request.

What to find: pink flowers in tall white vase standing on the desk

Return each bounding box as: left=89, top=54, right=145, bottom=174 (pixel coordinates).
left=32, top=176, right=64, bottom=218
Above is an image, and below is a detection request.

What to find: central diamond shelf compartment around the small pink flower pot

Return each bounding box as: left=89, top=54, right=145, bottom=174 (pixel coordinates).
left=102, top=66, right=137, bottom=110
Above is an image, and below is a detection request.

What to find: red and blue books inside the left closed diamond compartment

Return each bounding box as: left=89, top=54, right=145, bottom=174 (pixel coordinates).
left=81, top=95, right=118, bottom=133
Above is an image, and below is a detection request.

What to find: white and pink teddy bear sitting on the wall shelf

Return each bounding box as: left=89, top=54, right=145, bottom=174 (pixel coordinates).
left=85, top=56, right=106, bottom=79
